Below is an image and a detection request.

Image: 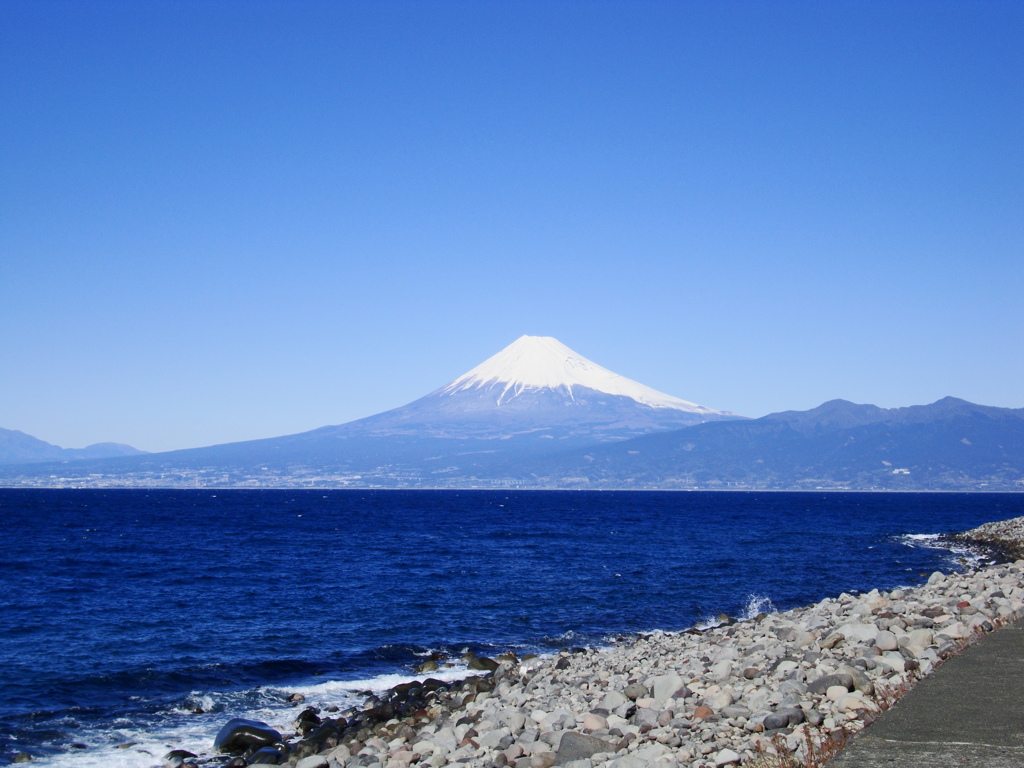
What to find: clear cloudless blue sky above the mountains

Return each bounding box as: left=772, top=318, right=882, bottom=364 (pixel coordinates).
left=0, top=0, right=1024, bottom=451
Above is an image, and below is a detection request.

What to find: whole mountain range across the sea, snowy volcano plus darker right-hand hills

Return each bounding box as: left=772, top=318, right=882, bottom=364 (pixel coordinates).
left=0, top=336, right=1024, bottom=490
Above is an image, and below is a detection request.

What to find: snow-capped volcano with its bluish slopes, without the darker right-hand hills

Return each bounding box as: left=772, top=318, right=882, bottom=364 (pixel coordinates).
left=0, top=336, right=739, bottom=485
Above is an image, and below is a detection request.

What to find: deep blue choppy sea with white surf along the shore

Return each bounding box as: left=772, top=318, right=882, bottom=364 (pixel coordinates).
left=0, top=489, right=1024, bottom=768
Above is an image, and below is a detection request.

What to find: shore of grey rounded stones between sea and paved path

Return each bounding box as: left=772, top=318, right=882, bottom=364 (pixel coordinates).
left=165, top=518, right=1024, bottom=768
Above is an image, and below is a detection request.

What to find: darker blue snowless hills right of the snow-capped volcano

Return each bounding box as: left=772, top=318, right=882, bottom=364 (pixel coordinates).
left=511, top=397, right=1024, bottom=489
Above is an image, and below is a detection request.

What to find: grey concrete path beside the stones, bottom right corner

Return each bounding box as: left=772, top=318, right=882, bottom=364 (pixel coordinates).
left=828, top=622, right=1024, bottom=768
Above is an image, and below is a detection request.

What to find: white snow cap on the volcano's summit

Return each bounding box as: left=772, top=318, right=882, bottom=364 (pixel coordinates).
left=438, top=336, right=720, bottom=414
